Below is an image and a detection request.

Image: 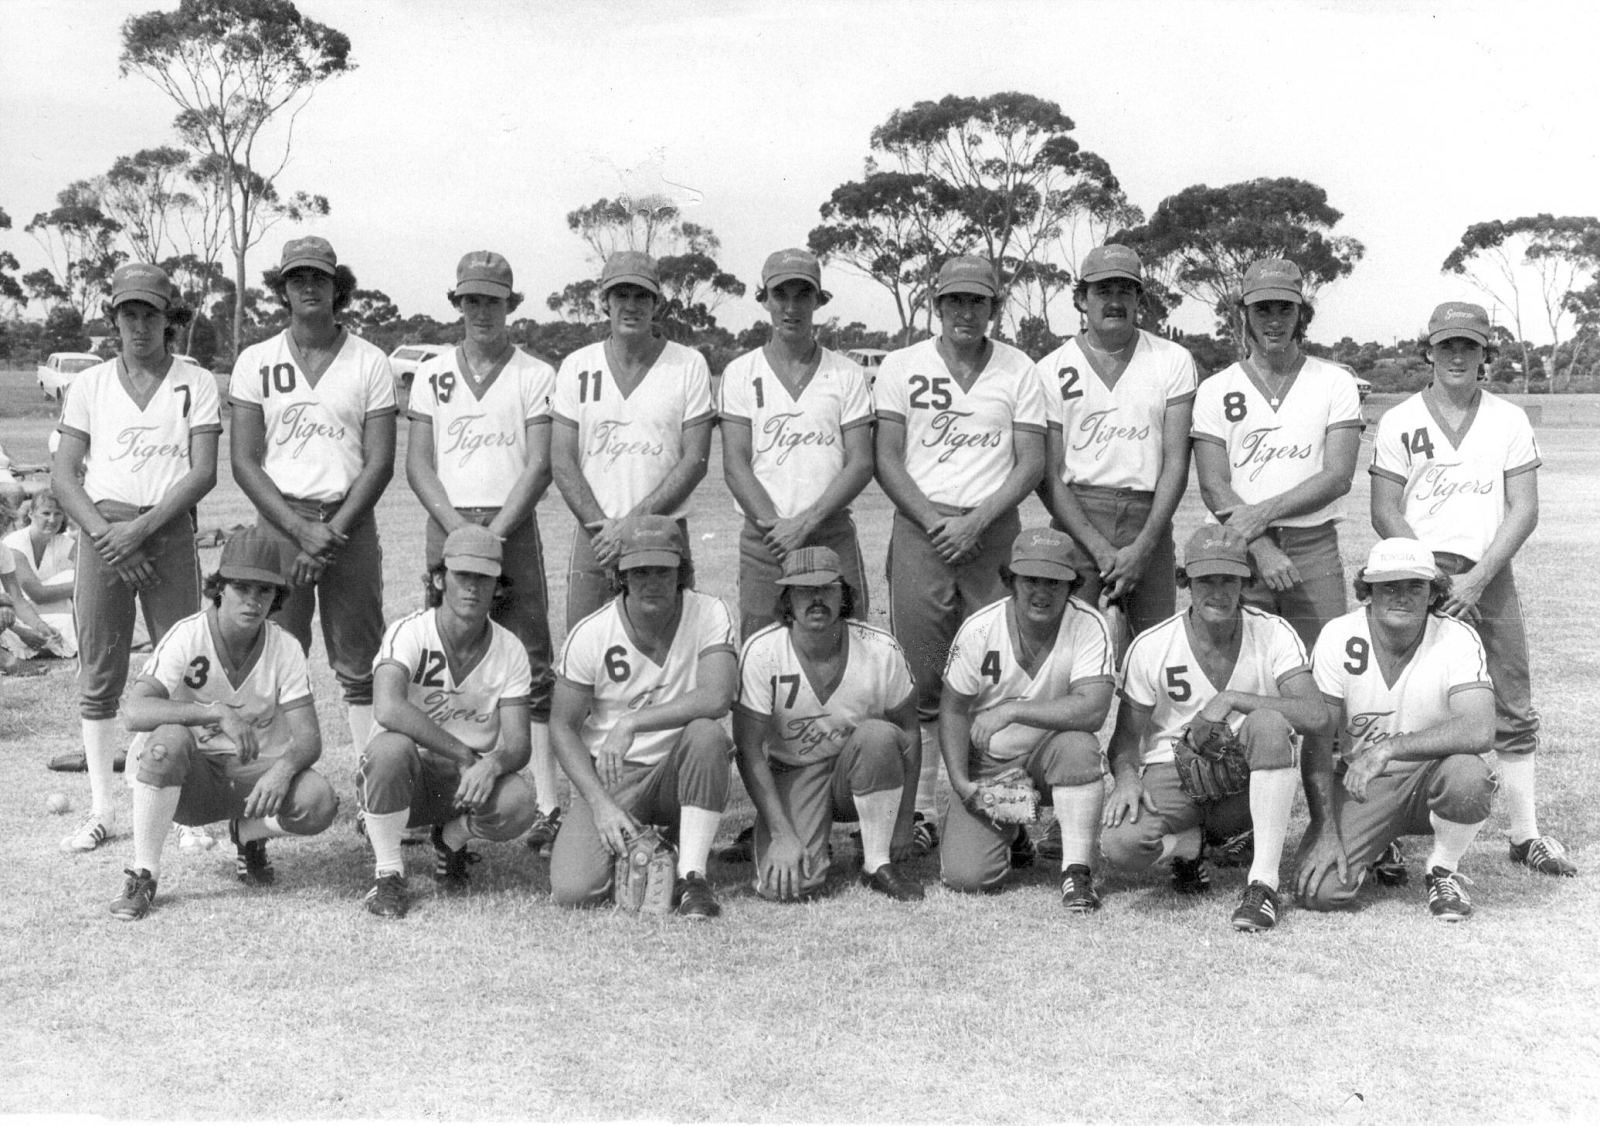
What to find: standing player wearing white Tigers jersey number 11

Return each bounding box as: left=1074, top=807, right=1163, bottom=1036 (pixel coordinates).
left=550, top=250, right=717, bottom=630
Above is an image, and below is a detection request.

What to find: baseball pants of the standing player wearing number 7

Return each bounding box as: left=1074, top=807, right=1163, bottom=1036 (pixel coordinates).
left=72, top=501, right=200, bottom=720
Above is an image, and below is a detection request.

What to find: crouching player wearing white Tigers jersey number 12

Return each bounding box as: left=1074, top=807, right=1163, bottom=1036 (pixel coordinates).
left=358, top=525, right=539, bottom=918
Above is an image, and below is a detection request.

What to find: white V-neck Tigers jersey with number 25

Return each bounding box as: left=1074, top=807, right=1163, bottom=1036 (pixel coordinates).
left=874, top=337, right=1050, bottom=509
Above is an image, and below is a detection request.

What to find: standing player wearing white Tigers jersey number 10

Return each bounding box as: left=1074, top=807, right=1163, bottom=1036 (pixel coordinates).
left=229, top=237, right=397, bottom=755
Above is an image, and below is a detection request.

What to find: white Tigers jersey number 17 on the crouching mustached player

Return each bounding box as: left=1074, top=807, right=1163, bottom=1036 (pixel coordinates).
left=739, top=622, right=915, bottom=766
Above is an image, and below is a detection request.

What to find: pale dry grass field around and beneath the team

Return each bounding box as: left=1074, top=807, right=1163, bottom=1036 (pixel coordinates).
left=0, top=373, right=1600, bottom=1123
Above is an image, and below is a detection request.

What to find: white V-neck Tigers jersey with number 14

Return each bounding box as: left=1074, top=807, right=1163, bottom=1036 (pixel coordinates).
left=1370, top=390, right=1539, bottom=561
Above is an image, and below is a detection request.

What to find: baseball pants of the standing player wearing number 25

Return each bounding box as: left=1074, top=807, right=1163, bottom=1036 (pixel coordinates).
left=888, top=505, right=1022, bottom=723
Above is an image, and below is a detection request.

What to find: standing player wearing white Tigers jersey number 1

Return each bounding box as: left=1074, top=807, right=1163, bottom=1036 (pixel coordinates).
left=722, top=250, right=872, bottom=638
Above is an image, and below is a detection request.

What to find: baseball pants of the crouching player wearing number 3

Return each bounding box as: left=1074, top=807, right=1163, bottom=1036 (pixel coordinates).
left=134, top=723, right=339, bottom=837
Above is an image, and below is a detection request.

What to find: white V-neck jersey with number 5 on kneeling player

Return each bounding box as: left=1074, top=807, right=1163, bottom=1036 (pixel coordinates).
left=1122, top=606, right=1310, bottom=766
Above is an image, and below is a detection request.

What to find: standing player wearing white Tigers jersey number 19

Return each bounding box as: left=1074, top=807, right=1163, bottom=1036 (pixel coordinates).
left=405, top=250, right=562, bottom=848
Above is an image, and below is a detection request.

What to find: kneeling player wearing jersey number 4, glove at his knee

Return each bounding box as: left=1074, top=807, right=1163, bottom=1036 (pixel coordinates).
left=939, top=528, right=1115, bottom=913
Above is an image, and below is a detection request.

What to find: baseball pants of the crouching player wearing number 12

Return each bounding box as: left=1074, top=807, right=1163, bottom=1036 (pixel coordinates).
left=357, top=729, right=539, bottom=841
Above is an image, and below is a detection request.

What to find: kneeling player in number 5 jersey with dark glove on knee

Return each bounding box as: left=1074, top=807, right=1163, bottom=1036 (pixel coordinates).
left=1101, top=525, right=1328, bottom=931
